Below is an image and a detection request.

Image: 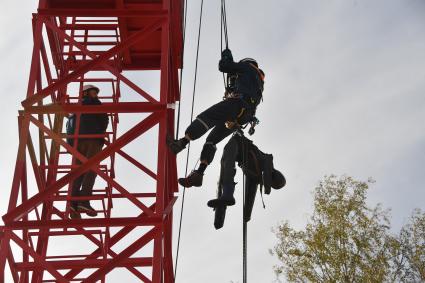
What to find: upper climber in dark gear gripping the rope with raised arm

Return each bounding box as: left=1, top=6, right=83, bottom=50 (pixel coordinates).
left=167, top=48, right=264, bottom=188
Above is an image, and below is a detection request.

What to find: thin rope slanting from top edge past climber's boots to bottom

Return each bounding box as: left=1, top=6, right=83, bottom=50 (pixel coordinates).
left=174, top=0, right=204, bottom=281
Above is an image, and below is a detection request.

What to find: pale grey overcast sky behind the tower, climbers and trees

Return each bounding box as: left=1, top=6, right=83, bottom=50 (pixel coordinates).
left=0, top=0, right=425, bottom=283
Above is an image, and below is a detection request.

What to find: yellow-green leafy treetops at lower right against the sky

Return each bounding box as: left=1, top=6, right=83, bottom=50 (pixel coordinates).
left=271, top=176, right=425, bottom=282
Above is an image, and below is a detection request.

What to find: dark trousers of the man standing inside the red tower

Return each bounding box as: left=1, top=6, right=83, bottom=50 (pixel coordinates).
left=71, top=139, right=103, bottom=210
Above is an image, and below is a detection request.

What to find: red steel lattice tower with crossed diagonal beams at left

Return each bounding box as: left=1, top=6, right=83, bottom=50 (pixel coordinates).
left=0, top=0, right=181, bottom=283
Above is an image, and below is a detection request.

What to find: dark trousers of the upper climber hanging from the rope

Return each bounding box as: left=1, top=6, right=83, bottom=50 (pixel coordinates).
left=185, top=99, right=247, bottom=164
